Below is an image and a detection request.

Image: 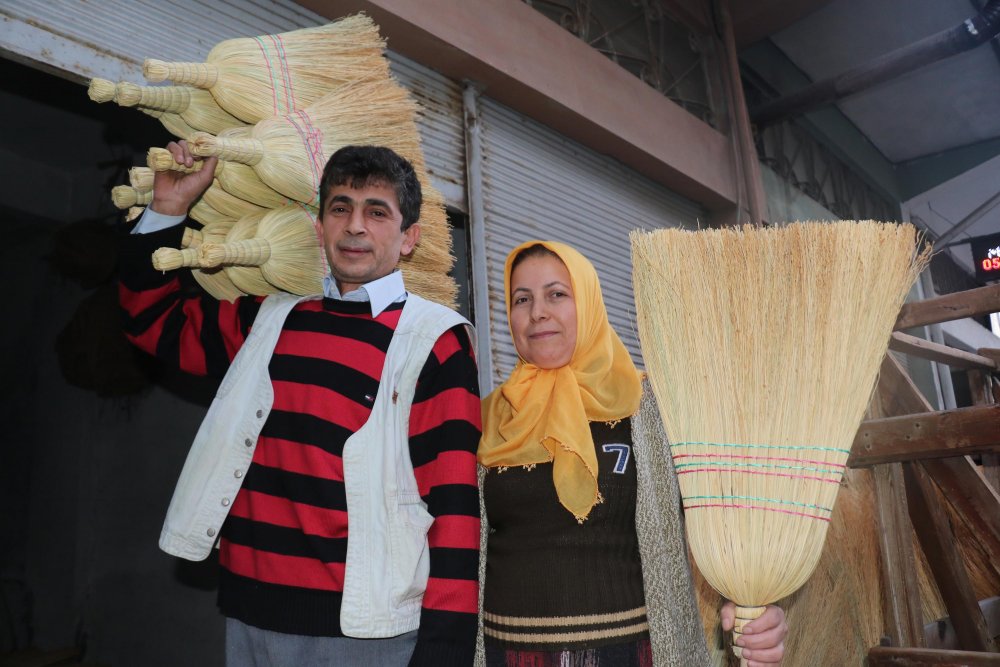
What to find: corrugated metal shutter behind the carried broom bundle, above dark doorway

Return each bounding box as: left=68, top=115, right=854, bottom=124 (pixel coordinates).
left=0, top=0, right=466, bottom=205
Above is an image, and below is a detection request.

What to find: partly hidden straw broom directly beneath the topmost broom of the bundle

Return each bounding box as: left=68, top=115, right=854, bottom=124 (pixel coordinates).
left=116, top=81, right=246, bottom=134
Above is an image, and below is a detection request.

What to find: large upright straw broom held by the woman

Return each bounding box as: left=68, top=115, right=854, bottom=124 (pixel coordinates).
left=631, top=221, right=930, bottom=655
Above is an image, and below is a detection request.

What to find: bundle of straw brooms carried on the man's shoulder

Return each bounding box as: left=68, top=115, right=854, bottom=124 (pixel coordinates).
left=89, top=15, right=457, bottom=306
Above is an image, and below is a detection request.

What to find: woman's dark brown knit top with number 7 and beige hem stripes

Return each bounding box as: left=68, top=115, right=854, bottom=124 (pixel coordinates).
left=483, top=420, right=648, bottom=650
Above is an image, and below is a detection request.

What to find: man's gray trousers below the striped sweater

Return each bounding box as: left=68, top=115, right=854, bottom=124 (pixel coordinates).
left=226, top=618, right=417, bottom=667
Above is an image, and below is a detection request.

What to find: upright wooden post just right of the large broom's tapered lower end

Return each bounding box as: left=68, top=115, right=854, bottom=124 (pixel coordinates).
left=872, top=463, right=924, bottom=646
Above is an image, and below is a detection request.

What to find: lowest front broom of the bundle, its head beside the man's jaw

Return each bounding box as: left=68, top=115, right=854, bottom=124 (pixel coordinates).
left=201, top=204, right=326, bottom=295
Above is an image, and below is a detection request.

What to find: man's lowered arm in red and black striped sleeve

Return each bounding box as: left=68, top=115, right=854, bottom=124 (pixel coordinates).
left=410, top=327, right=482, bottom=667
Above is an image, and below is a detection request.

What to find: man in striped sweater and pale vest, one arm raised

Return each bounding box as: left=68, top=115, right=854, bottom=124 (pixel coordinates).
left=120, top=141, right=480, bottom=667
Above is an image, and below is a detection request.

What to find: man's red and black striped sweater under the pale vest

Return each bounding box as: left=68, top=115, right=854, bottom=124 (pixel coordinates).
left=119, top=226, right=481, bottom=665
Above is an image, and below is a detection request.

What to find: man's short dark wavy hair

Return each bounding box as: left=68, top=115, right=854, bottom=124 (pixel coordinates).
left=319, top=146, right=423, bottom=230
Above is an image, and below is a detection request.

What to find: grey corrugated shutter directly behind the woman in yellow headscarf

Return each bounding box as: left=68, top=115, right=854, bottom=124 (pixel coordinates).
left=479, top=97, right=705, bottom=386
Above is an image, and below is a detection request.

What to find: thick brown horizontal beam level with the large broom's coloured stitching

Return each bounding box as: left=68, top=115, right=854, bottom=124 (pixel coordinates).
left=847, top=405, right=1000, bottom=468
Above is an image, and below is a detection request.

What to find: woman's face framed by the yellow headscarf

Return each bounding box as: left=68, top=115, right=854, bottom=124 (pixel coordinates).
left=510, top=255, right=576, bottom=368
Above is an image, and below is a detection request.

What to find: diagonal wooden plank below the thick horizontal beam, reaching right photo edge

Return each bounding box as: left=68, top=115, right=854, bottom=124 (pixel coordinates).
left=920, top=456, right=1000, bottom=563
